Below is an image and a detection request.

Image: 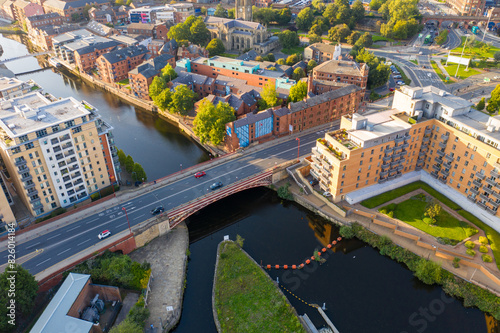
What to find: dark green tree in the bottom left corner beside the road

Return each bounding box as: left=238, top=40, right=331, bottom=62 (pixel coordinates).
left=0, top=264, right=38, bottom=332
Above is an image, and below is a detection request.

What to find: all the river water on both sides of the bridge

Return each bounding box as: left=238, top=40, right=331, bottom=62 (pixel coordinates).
left=0, top=36, right=487, bottom=333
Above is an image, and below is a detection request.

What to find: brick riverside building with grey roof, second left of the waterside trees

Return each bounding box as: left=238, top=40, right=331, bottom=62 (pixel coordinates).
left=97, top=45, right=149, bottom=83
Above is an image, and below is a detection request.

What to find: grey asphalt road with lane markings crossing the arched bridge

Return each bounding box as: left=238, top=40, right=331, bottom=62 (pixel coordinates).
left=0, top=125, right=338, bottom=274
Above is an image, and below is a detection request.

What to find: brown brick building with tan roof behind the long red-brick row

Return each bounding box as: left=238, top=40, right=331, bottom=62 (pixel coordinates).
left=312, top=60, right=370, bottom=90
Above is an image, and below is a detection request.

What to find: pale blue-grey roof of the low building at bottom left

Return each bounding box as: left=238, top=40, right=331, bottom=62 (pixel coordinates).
left=31, top=273, right=94, bottom=333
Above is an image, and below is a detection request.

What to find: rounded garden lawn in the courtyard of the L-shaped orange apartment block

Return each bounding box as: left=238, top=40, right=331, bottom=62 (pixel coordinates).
left=380, top=196, right=478, bottom=242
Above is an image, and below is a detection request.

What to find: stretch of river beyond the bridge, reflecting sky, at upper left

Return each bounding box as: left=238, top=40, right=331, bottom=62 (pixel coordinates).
left=0, top=35, right=209, bottom=180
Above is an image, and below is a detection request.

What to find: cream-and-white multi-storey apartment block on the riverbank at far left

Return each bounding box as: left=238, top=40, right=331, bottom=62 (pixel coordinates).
left=0, top=92, right=119, bottom=216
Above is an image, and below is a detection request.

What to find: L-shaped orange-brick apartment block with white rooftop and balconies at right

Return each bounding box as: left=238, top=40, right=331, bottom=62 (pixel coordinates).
left=311, top=86, right=500, bottom=217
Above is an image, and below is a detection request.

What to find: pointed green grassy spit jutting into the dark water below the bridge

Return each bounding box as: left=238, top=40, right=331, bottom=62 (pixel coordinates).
left=214, top=242, right=305, bottom=333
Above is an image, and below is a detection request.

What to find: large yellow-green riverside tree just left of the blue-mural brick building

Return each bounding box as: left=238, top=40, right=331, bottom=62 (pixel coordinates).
left=193, top=98, right=236, bottom=145
